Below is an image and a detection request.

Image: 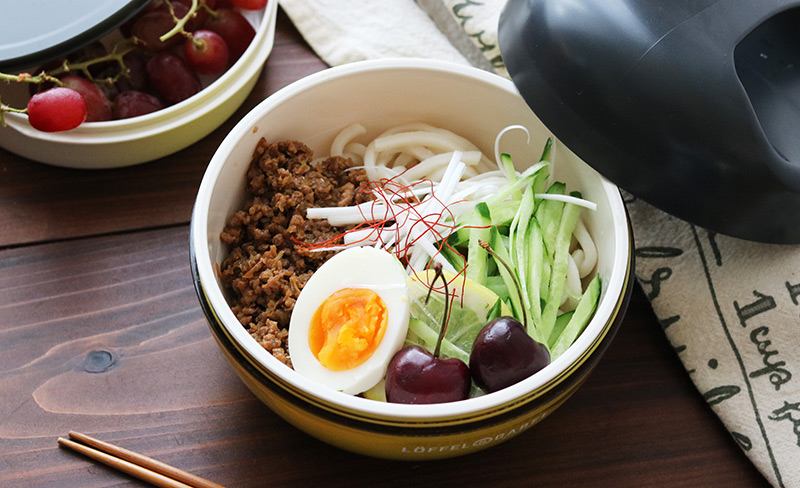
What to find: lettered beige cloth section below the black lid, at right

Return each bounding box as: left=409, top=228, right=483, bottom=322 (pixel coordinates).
left=627, top=194, right=800, bottom=486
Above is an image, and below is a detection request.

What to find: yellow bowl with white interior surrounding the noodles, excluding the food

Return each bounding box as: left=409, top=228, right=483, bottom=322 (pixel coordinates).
left=190, top=59, right=633, bottom=460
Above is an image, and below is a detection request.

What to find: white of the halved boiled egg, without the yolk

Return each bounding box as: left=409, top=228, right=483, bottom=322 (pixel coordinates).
left=289, top=247, right=409, bottom=395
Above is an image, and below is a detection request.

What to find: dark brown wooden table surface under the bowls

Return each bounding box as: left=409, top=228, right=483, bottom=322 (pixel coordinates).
left=0, top=8, right=766, bottom=487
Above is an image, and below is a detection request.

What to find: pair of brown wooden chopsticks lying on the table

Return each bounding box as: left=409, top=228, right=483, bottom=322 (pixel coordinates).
left=58, top=431, right=225, bottom=488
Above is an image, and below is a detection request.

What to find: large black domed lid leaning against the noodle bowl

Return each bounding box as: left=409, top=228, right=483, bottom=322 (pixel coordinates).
left=498, top=0, right=800, bottom=243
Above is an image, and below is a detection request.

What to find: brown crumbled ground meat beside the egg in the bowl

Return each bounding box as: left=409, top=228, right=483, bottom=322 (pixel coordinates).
left=220, top=139, right=367, bottom=366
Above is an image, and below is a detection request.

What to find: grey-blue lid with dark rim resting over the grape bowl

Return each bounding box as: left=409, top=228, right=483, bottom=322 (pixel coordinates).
left=0, top=0, right=150, bottom=72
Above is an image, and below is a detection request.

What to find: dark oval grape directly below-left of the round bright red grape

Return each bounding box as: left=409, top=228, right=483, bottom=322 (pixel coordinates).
left=147, top=51, right=202, bottom=105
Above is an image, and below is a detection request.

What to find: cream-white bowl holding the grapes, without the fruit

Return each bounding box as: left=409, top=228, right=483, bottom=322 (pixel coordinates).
left=0, top=1, right=278, bottom=169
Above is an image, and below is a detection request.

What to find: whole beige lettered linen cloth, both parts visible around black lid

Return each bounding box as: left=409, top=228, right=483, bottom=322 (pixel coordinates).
left=281, top=0, right=800, bottom=487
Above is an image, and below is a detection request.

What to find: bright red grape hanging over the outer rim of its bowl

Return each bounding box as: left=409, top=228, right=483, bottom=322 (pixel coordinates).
left=28, top=87, right=87, bottom=132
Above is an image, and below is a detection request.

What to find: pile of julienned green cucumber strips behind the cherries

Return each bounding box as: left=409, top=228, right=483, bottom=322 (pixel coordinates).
left=434, top=141, right=600, bottom=359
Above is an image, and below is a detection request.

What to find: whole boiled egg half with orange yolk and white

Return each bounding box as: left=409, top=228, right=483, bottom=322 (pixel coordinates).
left=289, top=247, right=409, bottom=395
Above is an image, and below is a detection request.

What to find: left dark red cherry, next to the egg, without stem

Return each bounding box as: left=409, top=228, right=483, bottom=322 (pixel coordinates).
left=386, top=346, right=471, bottom=404
